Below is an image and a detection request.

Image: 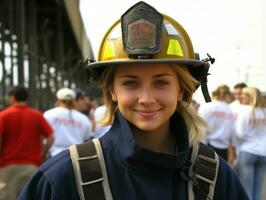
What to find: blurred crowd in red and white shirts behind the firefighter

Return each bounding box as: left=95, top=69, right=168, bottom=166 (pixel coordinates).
left=0, top=83, right=266, bottom=199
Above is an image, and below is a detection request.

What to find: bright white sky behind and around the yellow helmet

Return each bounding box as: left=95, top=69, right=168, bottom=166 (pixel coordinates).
left=80, top=0, right=266, bottom=101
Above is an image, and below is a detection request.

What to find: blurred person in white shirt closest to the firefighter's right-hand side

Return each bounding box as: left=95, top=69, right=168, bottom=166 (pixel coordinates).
left=198, top=85, right=234, bottom=163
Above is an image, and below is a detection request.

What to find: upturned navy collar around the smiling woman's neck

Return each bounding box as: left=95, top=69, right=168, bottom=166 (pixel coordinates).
left=108, top=111, right=190, bottom=171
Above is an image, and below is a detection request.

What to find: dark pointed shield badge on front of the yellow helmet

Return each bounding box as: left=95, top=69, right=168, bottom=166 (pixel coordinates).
left=121, top=1, right=163, bottom=59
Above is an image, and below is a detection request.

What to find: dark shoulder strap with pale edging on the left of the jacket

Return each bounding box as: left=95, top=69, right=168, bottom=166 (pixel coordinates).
left=69, top=139, right=113, bottom=200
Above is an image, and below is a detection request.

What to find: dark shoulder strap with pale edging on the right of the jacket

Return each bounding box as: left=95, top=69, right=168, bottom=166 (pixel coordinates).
left=188, top=143, right=219, bottom=200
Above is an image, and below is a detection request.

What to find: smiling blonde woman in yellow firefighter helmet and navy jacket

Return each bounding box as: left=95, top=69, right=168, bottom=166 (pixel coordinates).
left=19, top=1, right=248, bottom=200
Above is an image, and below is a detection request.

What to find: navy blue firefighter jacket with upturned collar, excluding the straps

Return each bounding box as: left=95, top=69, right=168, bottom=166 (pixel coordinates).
left=18, top=112, right=248, bottom=200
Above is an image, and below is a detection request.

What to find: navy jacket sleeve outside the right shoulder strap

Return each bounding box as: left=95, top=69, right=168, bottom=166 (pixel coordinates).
left=214, top=158, right=249, bottom=200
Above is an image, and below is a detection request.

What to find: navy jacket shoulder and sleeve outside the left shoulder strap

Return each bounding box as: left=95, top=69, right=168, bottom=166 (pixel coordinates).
left=18, top=150, right=79, bottom=200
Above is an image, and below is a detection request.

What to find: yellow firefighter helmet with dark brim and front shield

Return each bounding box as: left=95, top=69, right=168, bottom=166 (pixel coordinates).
left=85, top=1, right=214, bottom=101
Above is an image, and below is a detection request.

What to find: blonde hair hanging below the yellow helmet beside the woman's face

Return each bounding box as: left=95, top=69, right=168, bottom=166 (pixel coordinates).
left=97, top=65, right=207, bottom=144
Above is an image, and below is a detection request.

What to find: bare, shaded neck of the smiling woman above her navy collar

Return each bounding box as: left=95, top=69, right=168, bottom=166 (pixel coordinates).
left=133, top=120, right=176, bottom=154
